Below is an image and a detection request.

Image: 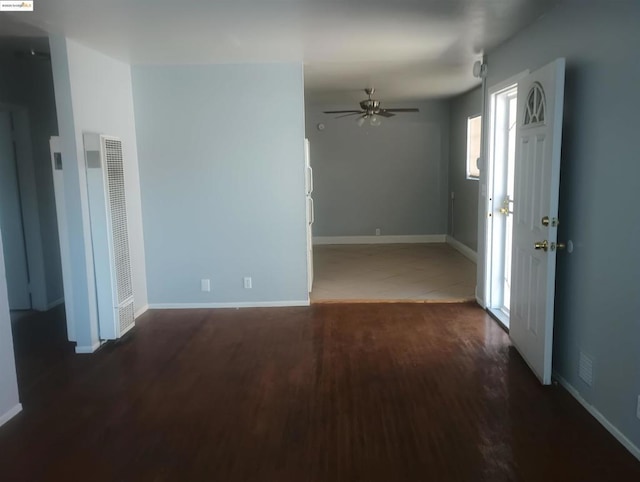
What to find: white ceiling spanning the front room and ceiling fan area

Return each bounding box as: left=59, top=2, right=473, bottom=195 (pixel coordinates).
left=0, top=0, right=559, bottom=103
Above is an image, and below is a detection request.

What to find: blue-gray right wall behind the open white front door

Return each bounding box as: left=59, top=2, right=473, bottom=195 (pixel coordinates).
left=480, top=1, right=640, bottom=446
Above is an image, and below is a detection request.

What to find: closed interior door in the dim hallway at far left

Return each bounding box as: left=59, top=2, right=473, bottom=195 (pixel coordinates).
left=0, top=111, right=31, bottom=310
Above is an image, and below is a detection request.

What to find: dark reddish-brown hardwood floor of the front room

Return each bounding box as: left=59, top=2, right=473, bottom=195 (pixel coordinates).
left=0, top=304, right=640, bottom=482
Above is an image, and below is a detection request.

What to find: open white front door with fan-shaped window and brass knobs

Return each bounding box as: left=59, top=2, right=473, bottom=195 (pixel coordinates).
left=509, top=59, right=565, bottom=385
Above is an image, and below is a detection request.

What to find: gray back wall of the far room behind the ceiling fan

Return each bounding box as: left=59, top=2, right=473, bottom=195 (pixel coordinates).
left=306, top=100, right=449, bottom=236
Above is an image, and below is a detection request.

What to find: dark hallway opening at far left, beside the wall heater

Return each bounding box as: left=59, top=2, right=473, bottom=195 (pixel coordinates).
left=0, top=34, right=73, bottom=403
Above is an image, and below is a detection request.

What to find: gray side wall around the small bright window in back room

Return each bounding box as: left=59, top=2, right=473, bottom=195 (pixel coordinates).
left=449, top=87, right=482, bottom=251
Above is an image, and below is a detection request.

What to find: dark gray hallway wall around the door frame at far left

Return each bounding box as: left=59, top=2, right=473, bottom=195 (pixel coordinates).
left=0, top=50, right=64, bottom=304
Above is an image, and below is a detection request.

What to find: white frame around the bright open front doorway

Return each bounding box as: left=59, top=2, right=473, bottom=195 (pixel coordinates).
left=478, top=69, right=530, bottom=322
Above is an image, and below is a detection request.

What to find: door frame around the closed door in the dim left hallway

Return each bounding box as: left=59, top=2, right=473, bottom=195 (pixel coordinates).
left=0, top=102, right=49, bottom=311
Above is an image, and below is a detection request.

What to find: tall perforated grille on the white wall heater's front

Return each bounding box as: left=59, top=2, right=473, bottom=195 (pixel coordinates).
left=104, top=139, right=133, bottom=304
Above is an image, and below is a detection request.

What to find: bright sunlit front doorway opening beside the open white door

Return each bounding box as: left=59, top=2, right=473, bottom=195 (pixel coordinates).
left=486, top=83, right=518, bottom=328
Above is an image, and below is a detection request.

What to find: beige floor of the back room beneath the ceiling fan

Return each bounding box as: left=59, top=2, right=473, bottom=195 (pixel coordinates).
left=311, top=243, right=476, bottom=302
